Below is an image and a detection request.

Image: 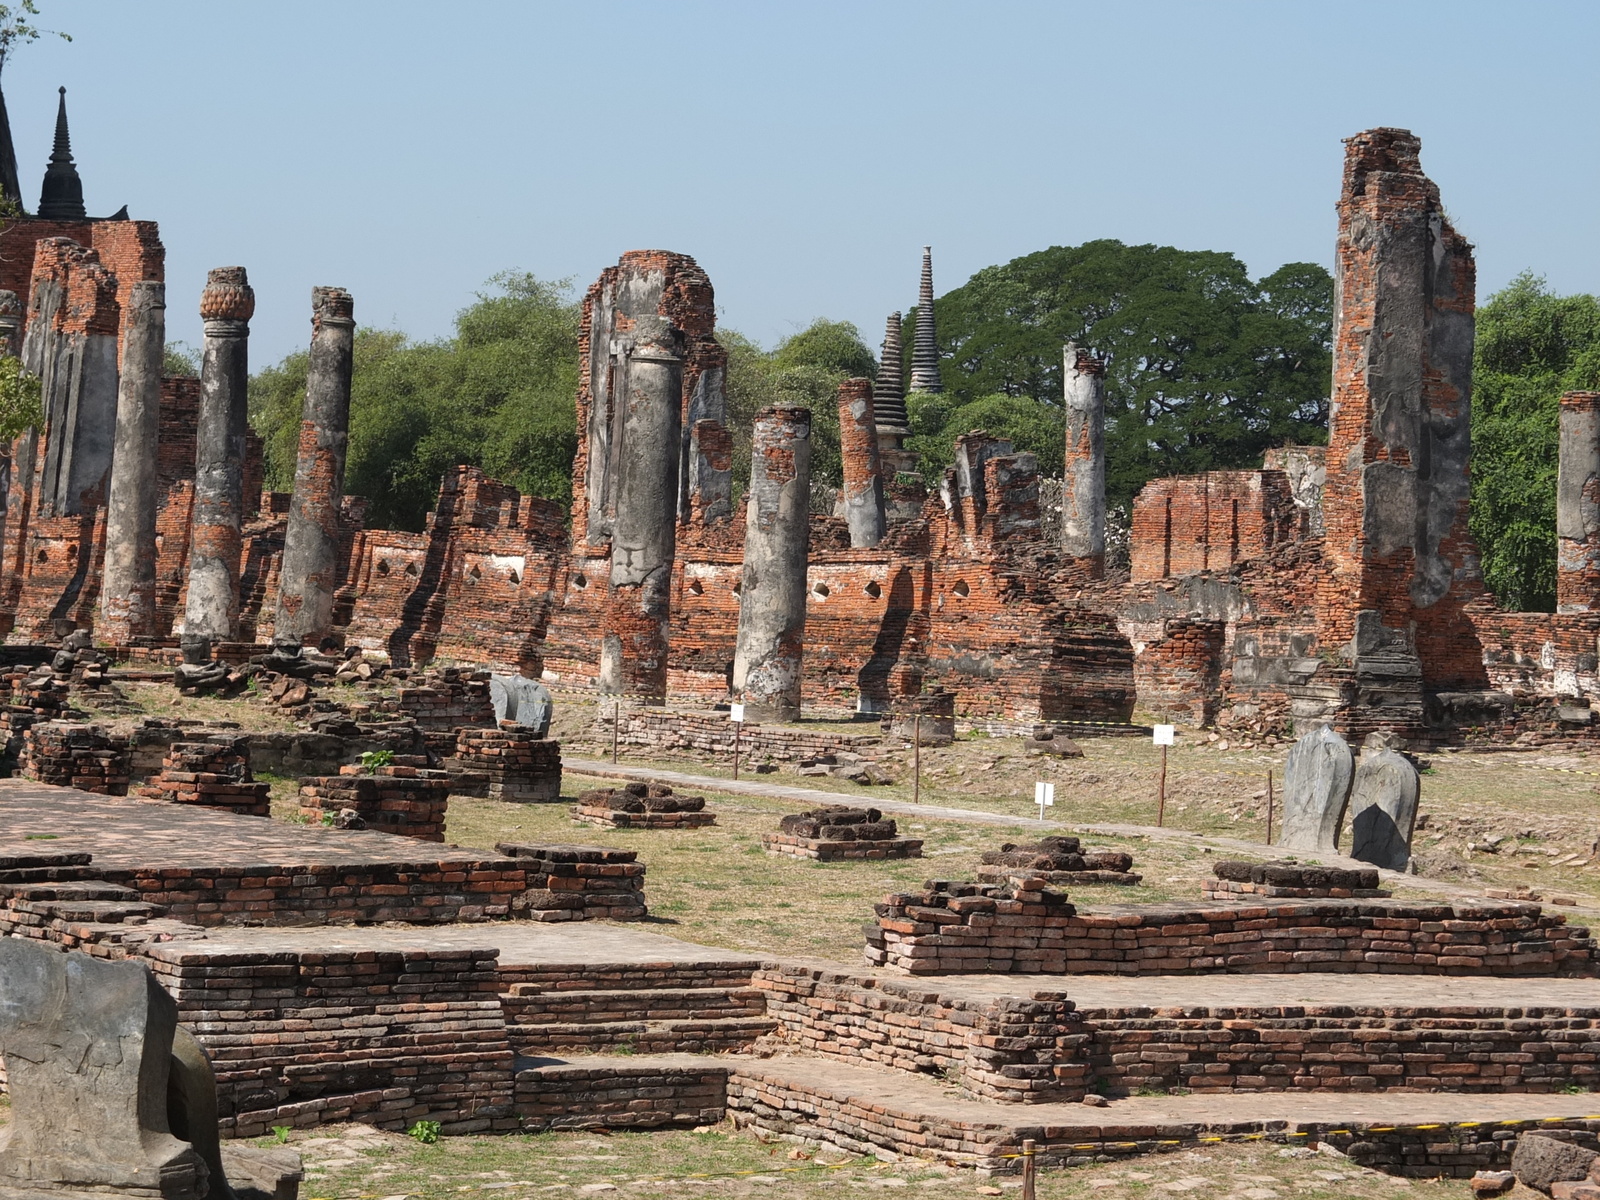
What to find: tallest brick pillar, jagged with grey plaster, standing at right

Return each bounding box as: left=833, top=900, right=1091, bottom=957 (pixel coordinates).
left=1318, top=130, right=1486, bottom=730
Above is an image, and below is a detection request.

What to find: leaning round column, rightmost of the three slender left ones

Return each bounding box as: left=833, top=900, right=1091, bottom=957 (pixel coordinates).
left=274, top=288, right=355, bottom=650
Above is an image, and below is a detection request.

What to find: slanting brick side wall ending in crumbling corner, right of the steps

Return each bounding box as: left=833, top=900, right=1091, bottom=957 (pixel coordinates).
left=752, top=963, right=1090, bottom=1104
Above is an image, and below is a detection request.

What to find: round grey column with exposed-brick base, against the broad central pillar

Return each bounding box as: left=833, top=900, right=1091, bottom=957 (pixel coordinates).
left=600, top=326, right=683, bottom=704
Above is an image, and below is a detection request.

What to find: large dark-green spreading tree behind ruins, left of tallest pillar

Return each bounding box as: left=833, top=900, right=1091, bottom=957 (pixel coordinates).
left=906, top=240, right=1333, bottom=504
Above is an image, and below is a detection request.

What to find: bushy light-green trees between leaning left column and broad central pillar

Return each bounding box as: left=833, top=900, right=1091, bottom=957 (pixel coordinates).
left=250, top=274, right=579, bottom=530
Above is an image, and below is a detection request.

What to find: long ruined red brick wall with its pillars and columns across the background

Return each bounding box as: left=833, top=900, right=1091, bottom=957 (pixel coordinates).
left=0, top=117, right=1600, bottom=752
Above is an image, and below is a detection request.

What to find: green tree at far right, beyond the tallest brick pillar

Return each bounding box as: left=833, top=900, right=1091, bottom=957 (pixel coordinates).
left=1472, top=272, right=1600, bottom=613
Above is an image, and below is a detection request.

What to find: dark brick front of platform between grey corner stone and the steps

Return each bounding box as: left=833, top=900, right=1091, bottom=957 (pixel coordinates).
left=144, top=942, right=518, bottom=1138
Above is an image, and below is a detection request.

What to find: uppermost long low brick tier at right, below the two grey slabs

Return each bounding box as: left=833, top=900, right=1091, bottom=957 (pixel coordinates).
left=866, top=883, right=1595, bottom=976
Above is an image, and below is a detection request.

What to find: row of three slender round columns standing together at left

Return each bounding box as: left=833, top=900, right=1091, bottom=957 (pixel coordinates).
left=86, top=267, right=355, bottom=662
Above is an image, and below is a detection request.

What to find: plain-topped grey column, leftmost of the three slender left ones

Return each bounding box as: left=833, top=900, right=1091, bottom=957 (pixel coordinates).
left=98, top=282, right=166, bottom=645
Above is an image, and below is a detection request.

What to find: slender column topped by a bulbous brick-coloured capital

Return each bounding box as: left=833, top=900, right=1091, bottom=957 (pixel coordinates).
left=182, top=267, right=256, bottom=661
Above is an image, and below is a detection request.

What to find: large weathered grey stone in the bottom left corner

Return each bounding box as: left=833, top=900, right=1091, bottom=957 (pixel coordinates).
left=0, top=938, right=208, bottom=1200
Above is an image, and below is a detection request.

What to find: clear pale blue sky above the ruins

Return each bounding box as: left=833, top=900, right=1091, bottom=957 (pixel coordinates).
left=3, top=0, right=1600, bottom=366
